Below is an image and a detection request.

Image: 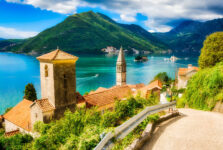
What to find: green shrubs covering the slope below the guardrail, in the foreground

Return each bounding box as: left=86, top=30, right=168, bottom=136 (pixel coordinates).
left=0, top=96, right=158, bottom=150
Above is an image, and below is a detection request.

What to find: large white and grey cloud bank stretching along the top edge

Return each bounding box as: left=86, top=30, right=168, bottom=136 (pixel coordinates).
left=7, top=0, right=223, bottom=32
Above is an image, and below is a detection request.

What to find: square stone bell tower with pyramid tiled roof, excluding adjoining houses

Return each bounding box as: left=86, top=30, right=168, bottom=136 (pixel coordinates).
left=37, top=48, right=78, bottom=118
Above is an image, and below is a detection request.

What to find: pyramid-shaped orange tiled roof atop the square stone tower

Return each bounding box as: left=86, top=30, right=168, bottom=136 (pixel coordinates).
left=37, top=49, right=78, bottom=61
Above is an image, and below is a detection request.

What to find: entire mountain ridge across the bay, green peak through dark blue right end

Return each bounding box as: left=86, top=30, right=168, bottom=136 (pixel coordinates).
left=0, top=11, right=223, bottom=54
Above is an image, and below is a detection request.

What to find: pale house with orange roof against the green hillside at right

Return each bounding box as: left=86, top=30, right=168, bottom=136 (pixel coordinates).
left=177, top=64, right=199, bottom=89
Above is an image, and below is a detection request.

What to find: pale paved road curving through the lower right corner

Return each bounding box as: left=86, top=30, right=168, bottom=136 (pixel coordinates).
left=142, top=109, right=223, bottom=150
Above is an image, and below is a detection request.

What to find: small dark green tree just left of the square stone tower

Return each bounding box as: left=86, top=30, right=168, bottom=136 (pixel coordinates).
left=24, top=83, right=37, bottom=101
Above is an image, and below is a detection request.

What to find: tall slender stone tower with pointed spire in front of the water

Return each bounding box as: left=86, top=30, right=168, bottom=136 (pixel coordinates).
left=116, top=47, right=126, bottom=85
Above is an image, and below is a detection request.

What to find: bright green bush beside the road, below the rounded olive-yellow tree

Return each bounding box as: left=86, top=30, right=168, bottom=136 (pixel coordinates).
left=177, top=63, right=223, bottom=110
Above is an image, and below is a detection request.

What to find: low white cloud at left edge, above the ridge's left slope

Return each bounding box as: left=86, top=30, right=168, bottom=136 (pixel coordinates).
left=0, top=26, right=38, bottom=39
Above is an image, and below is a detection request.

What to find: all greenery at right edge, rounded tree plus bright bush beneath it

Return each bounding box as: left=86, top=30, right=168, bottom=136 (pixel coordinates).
left=177, top=32, right=223, bottom=110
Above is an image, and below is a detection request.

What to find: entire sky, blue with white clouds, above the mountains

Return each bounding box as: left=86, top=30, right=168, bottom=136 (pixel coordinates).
left=0, top=0, right=223, bottom=39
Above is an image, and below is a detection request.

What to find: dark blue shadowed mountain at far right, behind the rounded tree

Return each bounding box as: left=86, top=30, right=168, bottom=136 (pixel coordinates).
left=153, top=18, right=223, bottom=52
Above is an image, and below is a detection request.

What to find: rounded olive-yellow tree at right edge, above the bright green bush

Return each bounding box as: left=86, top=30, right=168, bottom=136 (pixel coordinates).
left=198, top=32, right=223, bottom=69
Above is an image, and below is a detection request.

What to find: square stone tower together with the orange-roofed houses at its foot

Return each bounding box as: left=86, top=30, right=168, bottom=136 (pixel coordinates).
left=4, top=49, right=80, bottom=134
